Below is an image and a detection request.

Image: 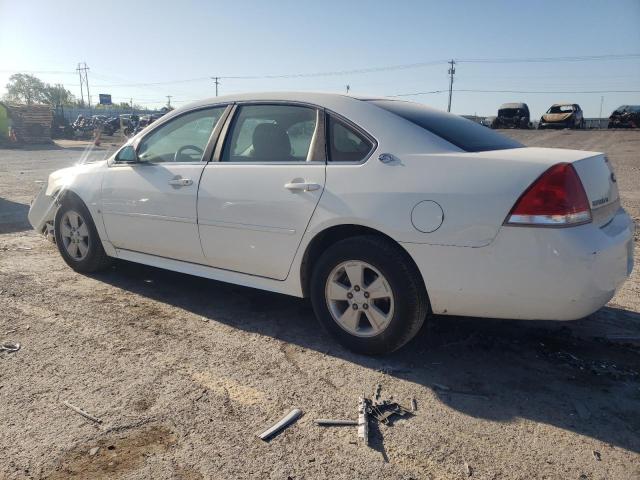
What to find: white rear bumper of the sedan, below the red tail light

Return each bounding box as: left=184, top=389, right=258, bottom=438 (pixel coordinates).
left=403, top=209, right=634, bottom=320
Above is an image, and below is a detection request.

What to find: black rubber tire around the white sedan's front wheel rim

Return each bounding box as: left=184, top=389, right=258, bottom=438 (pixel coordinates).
left=54, top=196, right=113, bottom=273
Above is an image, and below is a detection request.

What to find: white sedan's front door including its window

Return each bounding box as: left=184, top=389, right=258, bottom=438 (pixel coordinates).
left=102, top=106, right=226, bottom=263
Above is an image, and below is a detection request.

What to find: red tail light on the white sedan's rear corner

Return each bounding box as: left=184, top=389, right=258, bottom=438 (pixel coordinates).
left=505, top=163, right=591, bottom=227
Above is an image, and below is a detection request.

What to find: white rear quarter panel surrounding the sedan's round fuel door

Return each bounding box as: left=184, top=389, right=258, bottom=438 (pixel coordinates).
left=308, top=147, right=596, bottom=247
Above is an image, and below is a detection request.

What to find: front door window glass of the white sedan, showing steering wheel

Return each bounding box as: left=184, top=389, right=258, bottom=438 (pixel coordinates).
left=138, top=107, right=226, bottom=163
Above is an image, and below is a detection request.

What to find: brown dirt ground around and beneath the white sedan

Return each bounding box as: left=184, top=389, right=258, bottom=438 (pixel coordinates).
left=0, top=131, right=640, bottom=480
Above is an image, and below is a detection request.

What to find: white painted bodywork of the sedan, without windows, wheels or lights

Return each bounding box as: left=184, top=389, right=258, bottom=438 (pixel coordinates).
left=29, top=93, right=634, bottom=320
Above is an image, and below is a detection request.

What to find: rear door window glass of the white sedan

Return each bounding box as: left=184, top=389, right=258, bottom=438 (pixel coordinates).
left=221, top=105, right=317, bottom=163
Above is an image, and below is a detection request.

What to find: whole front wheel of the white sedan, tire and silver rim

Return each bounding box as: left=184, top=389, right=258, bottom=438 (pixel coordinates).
left=54, top=198, right=111, bottom=273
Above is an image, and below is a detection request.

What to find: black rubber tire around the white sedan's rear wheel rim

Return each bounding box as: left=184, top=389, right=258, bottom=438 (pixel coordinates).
left=311, top=235, right=429, bottom=355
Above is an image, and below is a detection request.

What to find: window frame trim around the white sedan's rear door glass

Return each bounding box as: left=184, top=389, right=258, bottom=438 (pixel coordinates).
left=210, top=100, right=327, bottom=166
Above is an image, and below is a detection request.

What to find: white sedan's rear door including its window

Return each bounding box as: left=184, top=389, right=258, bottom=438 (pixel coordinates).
left=198, top=104, right=326, bottom=280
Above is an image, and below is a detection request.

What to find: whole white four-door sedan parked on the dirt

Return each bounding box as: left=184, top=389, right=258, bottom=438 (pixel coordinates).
left=29, top=93, right=634, bottom=354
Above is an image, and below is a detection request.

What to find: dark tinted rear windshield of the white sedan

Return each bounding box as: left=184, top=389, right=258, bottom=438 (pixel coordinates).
left=367, top=100, right=523, bottom=152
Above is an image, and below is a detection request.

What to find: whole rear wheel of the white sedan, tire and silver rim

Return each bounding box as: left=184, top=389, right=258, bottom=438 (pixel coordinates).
left=311, top=236, right=428, bottom=355
